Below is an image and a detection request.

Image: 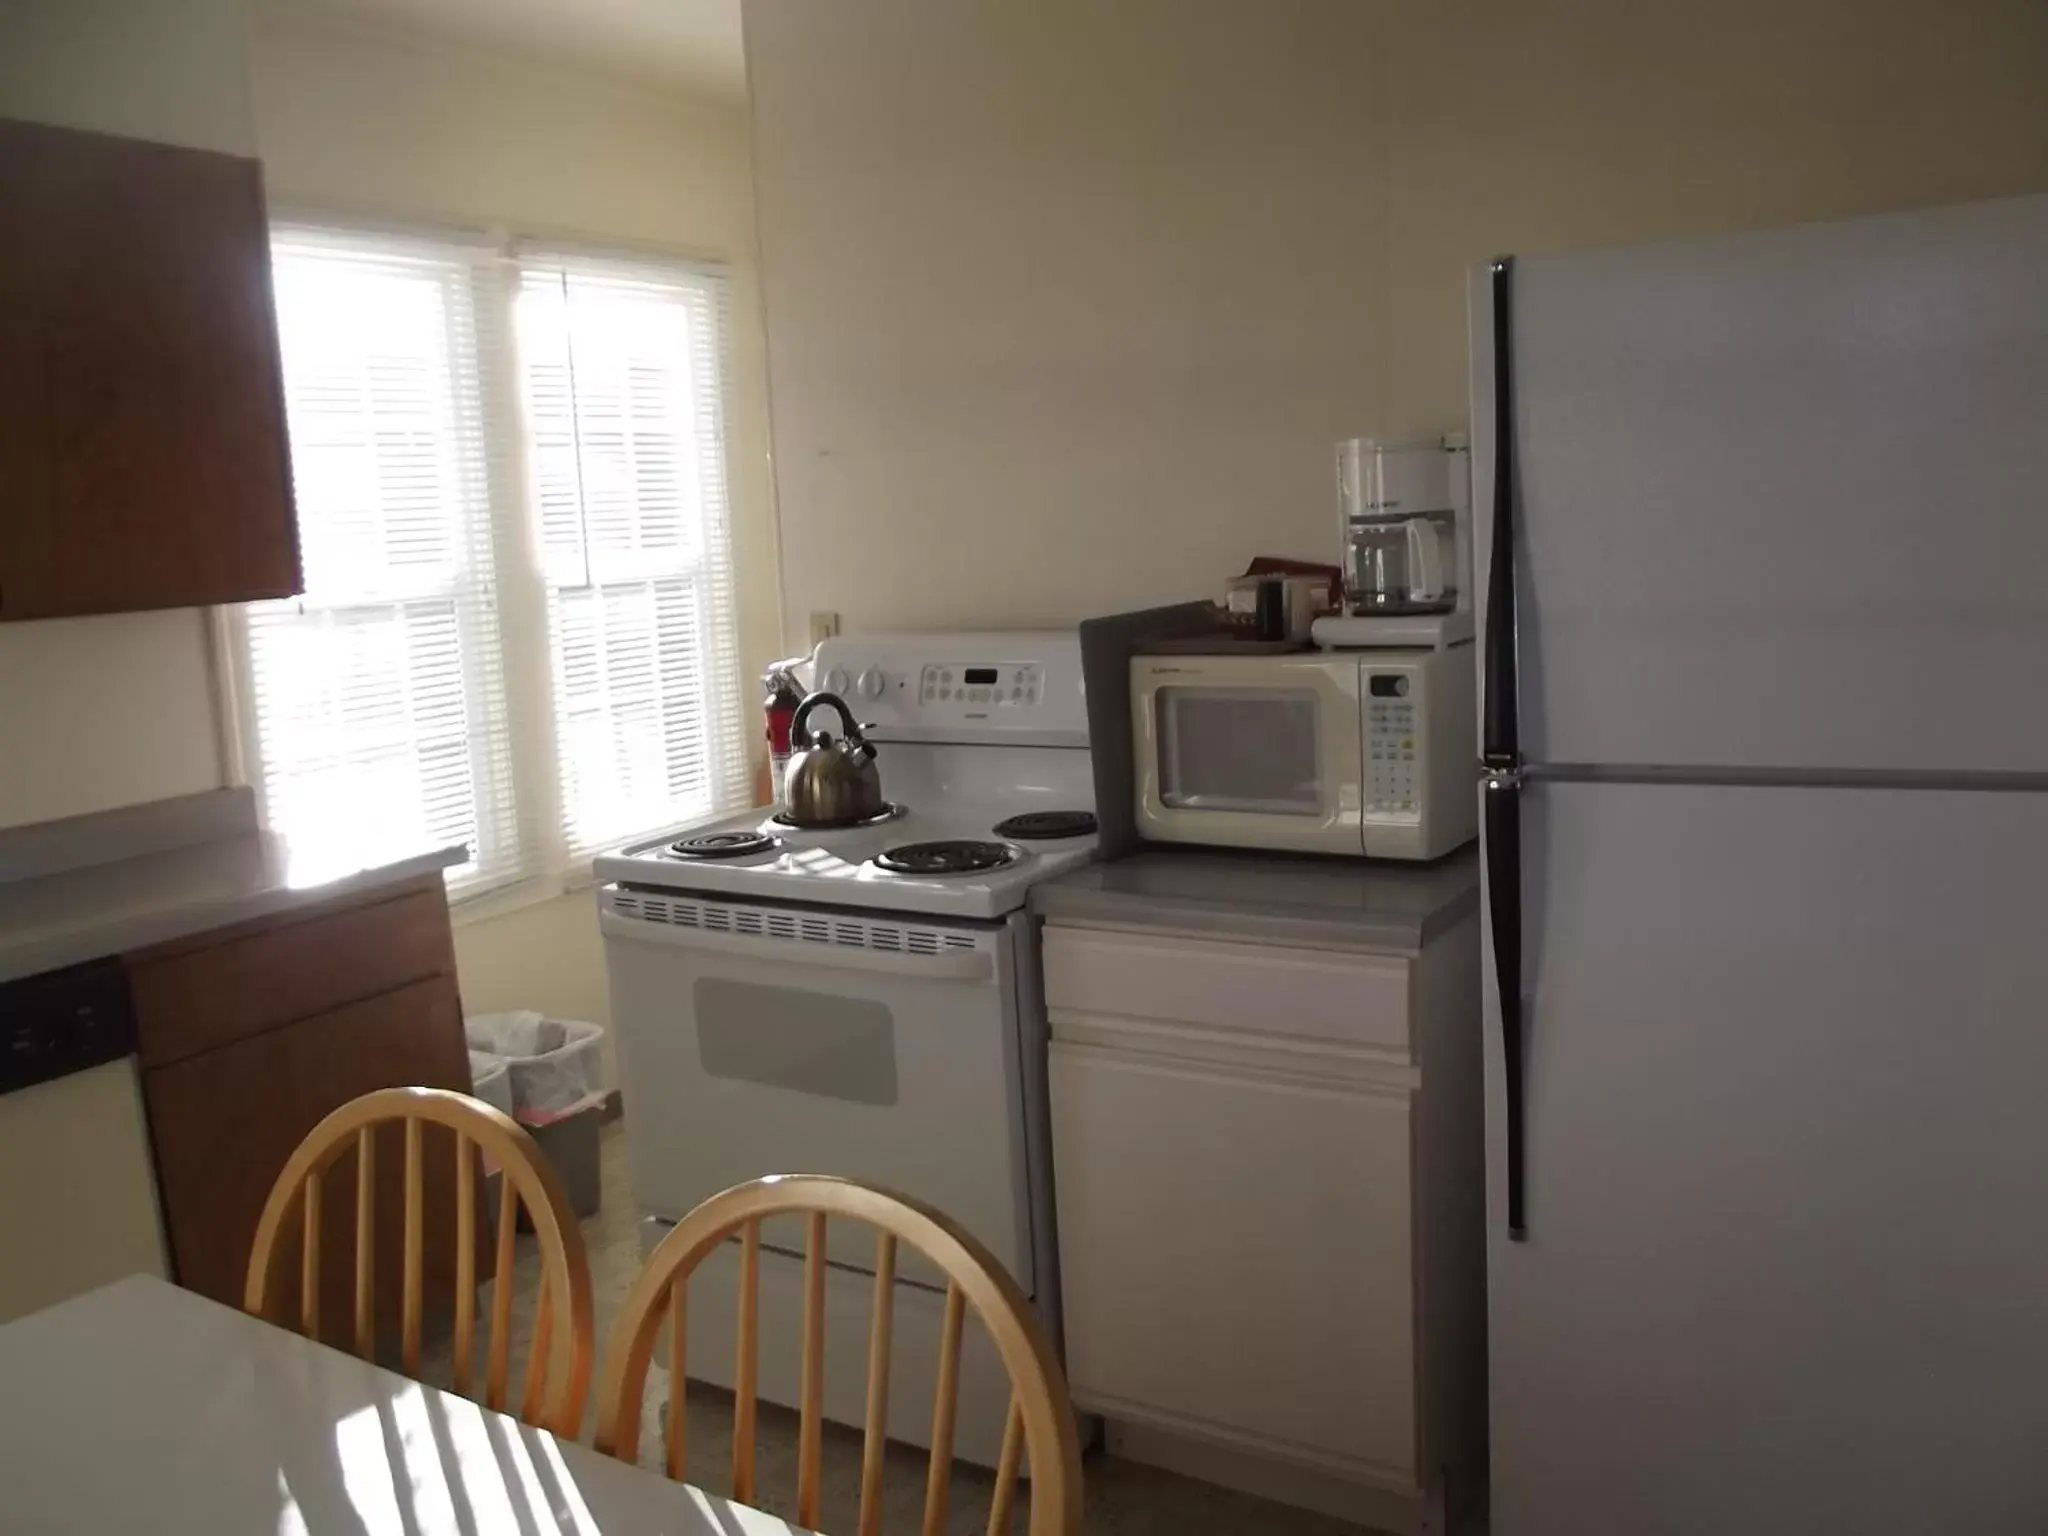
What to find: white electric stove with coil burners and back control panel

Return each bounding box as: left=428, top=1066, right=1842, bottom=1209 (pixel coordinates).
left=596, top=633, right=1096, bottom=1464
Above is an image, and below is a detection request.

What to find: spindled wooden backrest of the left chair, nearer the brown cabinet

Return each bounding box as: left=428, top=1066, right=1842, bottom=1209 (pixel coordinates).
left=242, top=1087, right=594, bottom=1438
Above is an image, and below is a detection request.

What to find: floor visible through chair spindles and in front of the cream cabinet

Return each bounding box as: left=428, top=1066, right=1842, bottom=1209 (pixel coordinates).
left=422, top=1122, right=1362, bottom=1536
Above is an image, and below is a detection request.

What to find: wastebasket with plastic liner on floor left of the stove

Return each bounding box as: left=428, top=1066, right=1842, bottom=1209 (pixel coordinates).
left=465, top=1010, right=604, bottom=1223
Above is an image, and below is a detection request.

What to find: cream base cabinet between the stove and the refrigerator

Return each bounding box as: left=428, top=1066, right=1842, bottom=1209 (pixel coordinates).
left=1044, top=924, right=1485, bottom=1530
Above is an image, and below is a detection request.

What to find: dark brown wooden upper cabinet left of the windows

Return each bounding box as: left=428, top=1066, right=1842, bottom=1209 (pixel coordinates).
left=0, top=121, right=301, bottom=618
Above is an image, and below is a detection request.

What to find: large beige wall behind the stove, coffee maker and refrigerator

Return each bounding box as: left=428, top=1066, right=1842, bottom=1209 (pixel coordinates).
left=745, top=0, right=2048, bottom=633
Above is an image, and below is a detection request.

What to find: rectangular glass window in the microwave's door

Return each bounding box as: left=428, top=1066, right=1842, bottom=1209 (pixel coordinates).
left=1155, top=686, right=1323, bottom=815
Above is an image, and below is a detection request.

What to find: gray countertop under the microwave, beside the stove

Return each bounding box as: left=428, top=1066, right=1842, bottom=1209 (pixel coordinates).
left=1030, top=846, right=1479, bottom=952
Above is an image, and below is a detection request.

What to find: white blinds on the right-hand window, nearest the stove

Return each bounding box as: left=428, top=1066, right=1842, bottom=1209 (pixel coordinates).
left=518, top=254, right=750, bottom=872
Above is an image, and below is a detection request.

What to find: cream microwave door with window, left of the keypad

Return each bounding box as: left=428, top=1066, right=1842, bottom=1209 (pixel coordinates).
left=1130, top=655, right=1364, bottom=854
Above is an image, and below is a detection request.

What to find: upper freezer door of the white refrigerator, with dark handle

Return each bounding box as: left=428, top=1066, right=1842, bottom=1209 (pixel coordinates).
left=1473, top=197, right=2048, bottom=772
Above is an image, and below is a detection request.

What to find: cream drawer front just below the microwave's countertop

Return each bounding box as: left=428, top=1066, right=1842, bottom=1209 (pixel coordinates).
left=1044, top=926, right=1409, bottom=1057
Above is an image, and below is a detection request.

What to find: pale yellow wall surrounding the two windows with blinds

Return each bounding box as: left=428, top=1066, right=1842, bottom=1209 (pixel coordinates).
left=252, top=0, right=778, bottom=1048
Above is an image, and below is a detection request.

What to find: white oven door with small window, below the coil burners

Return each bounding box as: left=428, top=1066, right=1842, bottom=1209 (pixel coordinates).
left=600, top=887, right=1032, bottom=1288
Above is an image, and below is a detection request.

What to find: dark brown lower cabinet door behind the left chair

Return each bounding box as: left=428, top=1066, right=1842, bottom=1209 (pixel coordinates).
left=143, top=977, right=469, bottom=1339
